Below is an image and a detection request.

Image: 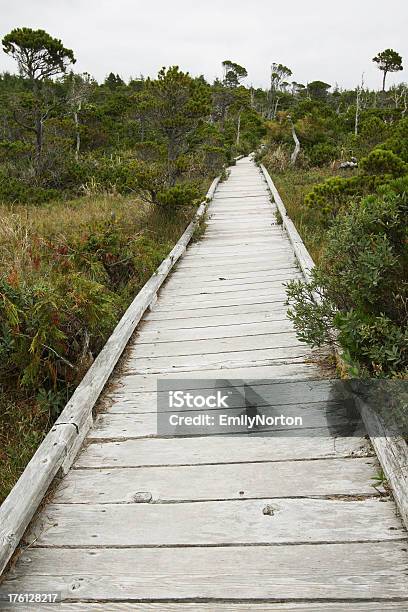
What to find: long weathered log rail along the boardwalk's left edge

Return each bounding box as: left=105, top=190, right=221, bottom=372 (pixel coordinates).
left=0, top=177, right=220, bottom=574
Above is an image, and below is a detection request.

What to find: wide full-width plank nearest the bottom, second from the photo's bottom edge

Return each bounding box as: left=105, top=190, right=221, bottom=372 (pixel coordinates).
left=3, top=544, right=408, bottom=600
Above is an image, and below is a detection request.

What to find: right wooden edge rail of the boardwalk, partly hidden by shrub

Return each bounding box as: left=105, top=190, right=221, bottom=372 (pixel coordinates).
left=260, top=164, right=408, bottom=529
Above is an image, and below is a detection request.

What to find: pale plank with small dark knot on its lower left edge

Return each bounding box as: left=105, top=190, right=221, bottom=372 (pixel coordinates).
left=52, top=458, right=378, bottom=504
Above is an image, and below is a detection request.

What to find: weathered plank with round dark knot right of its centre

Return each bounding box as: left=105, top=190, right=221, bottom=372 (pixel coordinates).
left=25, top=498, right=406, bottom=548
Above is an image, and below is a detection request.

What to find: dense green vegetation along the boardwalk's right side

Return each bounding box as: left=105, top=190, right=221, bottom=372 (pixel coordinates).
left=259, top=59, right=408, bottom=378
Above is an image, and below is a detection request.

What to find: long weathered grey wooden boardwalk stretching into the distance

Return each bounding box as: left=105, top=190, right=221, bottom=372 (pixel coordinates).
left=0, top=158, right=408, bottom=612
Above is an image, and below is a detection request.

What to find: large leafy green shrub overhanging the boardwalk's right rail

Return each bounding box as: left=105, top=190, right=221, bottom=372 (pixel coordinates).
left=288, top=183, right=408, bottom=376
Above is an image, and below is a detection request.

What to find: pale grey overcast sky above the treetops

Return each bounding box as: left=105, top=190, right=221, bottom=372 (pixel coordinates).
left=0, top=0, right=408, bottom=87
